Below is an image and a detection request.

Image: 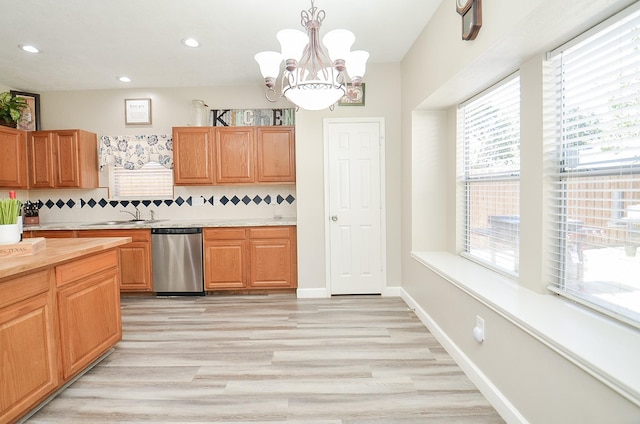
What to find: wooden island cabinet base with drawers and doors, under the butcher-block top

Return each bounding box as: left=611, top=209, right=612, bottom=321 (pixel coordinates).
left=0, top=245, right=122, bottom=423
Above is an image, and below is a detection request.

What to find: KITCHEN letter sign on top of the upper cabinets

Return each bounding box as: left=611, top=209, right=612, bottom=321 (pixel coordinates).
left=211, top=108, right=295, bottom=127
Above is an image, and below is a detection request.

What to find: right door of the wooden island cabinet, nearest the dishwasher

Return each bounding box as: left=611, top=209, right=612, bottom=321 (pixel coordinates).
left=58, top=267, right=122, bottom=380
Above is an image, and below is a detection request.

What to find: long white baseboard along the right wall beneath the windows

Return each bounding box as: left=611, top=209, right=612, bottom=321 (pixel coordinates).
left=400, top=287, right=528, bottom=424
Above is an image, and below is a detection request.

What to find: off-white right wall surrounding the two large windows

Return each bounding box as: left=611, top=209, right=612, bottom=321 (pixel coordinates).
left=401, top=0, right=640, bottom=423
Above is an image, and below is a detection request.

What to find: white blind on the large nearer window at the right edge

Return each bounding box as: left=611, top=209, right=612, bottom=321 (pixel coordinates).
left=549, top=3, right=640, bottom=325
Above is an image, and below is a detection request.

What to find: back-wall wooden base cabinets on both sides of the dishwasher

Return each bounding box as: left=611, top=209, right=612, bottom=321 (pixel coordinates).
left=29, top=226, right=298, bottom=292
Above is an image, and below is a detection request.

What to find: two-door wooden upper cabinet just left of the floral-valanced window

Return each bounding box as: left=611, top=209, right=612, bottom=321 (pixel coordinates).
left=28, top=130, right=98, bottom=188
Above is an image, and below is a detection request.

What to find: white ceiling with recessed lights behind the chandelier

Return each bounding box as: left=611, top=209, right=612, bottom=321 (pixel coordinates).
left=0, top=0, right=442, bottom=93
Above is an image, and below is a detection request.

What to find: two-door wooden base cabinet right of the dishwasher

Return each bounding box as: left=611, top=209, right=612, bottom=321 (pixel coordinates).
left=204, top=226, right=297, bottom=291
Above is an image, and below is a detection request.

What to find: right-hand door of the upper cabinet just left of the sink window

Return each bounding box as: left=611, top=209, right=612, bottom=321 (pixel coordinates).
left=53, top=131, right=80, bottom=187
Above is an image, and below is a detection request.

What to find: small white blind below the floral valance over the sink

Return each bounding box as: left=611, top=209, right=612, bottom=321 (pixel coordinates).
left=109, top=162, right=173, bottom=200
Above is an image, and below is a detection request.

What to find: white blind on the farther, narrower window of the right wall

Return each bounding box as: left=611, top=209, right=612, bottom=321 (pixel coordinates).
left=458, top=75, right=520, bottom=275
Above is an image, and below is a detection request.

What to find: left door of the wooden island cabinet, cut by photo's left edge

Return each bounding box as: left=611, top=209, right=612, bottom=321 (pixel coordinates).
left=0, top=273, right=58, bottom=423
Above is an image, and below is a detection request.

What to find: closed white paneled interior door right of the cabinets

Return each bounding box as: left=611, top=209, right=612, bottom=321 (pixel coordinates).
left=325, top=120, right=384, bottom=295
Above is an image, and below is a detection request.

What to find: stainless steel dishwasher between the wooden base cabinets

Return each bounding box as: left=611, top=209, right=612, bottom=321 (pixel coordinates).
left=151, top=228, right=204, bottom=296
